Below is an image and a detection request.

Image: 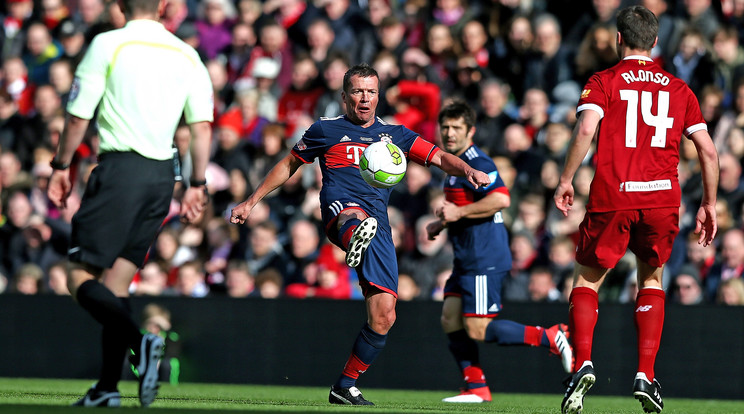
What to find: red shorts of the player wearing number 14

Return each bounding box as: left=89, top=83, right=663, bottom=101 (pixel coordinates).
left=576, top=207, right=679, bottom=269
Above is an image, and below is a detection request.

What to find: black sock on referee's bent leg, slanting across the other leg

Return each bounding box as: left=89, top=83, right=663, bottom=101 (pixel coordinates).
left=77, top=279, right=142, bottom=352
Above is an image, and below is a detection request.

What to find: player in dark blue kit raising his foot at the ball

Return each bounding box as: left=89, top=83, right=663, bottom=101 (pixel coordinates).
left=230, top=64, right=491, bottom=405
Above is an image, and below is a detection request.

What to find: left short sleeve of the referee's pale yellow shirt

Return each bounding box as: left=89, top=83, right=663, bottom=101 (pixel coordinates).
left=67, top=36, right=109, bottom=119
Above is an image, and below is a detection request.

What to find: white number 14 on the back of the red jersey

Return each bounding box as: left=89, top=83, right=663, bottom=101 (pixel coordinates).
left=620, top=89, right=674, bottom=148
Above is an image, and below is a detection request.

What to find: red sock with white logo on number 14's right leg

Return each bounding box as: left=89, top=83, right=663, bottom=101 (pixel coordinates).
left=634, top=288, right=666, bottom=381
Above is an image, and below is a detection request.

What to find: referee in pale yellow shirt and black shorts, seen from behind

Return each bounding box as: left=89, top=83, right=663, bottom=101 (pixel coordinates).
left=48, top=0, right=213, bottom=407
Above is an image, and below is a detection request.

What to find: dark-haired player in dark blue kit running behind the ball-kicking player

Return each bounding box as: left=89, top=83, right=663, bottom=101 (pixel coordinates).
left=426, top=102, right=573, bottom=403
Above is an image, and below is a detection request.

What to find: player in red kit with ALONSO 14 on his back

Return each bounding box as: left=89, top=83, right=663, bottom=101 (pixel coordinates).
left=554, top=6, right=718, bottom=414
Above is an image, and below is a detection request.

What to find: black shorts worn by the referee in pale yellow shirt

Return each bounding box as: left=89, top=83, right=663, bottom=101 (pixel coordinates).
left=69, top=152, right=174, bottom=269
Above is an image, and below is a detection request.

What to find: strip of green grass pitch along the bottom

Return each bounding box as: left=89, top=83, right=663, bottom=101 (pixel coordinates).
left=0, top=378, right=744, bottom=414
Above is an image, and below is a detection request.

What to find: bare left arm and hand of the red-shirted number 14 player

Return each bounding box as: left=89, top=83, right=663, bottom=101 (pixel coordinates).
left=553, top=110, right=600, bottom=217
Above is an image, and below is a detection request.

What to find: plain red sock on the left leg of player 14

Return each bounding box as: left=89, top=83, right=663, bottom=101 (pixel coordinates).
left=568, top=287, right=599, bottom=369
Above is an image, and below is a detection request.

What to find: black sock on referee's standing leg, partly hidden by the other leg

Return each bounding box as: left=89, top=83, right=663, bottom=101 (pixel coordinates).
left=96, top=297, right=132, bottom=391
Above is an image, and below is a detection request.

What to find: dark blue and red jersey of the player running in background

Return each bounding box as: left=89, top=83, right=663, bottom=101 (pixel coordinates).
left=444, top=146, right=512, bottom=274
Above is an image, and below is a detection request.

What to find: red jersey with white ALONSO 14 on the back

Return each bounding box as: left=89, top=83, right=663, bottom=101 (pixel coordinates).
left=577, top=56, right=708, bottom=212
